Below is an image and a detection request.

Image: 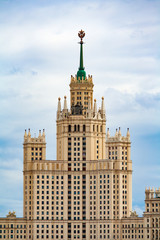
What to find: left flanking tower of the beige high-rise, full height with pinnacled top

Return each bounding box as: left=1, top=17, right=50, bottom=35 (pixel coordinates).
left=23, top=129, right=46, bottom=219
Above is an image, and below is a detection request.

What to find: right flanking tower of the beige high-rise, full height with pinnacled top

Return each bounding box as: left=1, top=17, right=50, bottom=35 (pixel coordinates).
left=106, top=128, right=132, bottom=219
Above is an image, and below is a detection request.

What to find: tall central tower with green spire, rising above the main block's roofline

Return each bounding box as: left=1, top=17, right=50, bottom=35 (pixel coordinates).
left=57, top=30, right=106, bottom=163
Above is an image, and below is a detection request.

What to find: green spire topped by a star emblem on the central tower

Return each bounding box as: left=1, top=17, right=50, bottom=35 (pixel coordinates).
left=77, top=30, right=86, bottom=80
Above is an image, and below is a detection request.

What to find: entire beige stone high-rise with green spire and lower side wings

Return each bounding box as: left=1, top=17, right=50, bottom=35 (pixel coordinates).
left=0, top=30, right=160, bottom=240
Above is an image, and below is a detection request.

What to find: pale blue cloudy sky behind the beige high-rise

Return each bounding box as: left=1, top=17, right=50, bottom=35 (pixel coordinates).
left=0, top=0, right=160, bottom=217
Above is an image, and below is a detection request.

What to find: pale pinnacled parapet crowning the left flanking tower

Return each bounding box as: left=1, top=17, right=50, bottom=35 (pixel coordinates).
left=24, top=128, right=46, bottom=144
